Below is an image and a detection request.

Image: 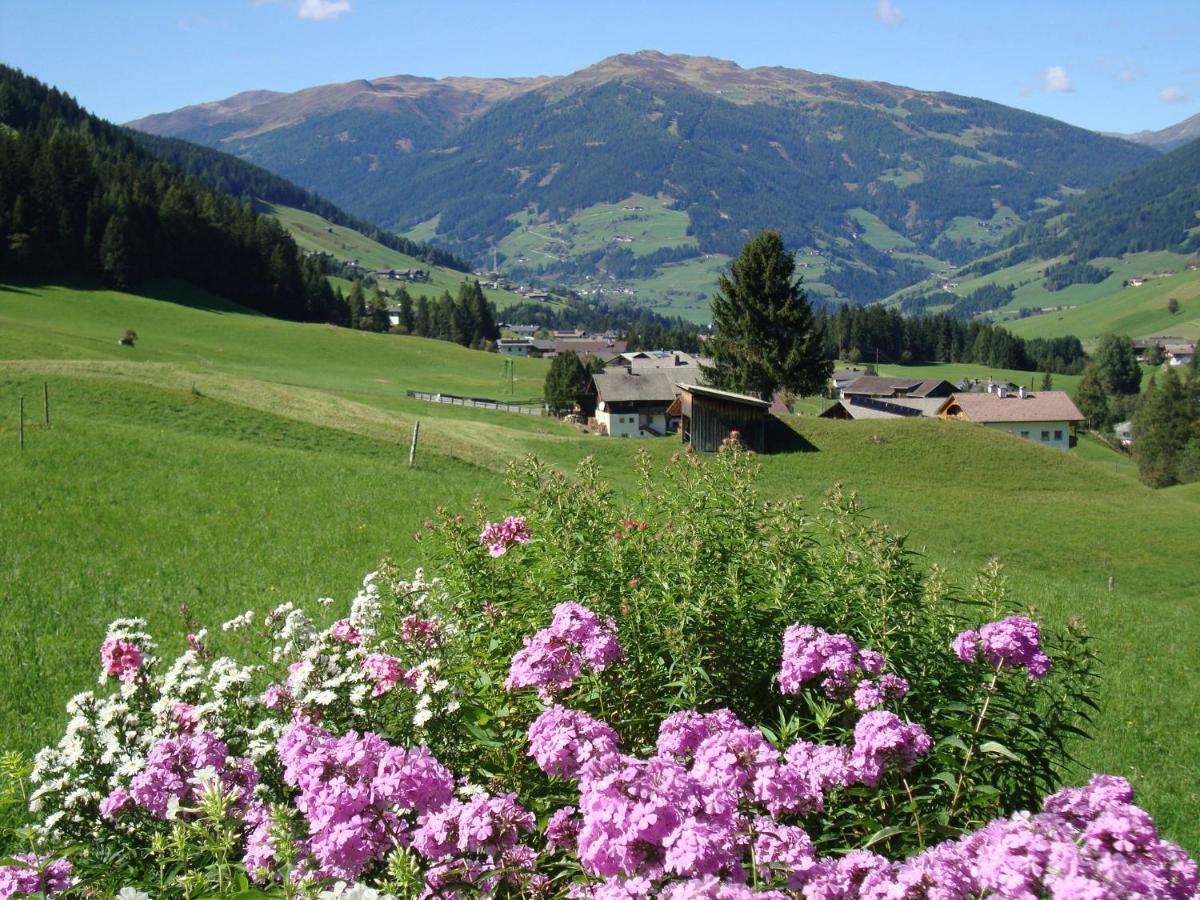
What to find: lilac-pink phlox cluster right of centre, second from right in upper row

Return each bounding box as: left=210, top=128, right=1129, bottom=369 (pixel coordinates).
left=779, top=624, right=908, bottom=710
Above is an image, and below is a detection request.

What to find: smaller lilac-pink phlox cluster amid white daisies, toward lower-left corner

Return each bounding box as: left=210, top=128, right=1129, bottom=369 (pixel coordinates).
left=121, top=732, right=258, bottom=818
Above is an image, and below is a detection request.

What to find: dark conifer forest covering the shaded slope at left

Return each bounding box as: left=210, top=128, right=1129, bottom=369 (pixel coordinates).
left=0, top=66, right=349, bottom=324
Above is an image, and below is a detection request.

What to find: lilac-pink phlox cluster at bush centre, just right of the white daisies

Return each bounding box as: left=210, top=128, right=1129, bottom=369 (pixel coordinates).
left=504, top=602, right=624, bottom=702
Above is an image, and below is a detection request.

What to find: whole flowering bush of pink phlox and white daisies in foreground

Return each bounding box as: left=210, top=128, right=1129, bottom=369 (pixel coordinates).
left=0, top=443, right=1198, bottom=900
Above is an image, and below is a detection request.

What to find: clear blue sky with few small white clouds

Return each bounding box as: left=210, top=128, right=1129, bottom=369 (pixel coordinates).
left=0, top=0, right=1200, bottom=132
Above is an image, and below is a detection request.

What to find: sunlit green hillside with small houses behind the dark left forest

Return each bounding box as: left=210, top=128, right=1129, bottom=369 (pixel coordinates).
left=258, top=203, right=549, bottom=310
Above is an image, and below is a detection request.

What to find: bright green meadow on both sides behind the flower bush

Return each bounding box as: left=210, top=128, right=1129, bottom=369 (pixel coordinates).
left=0, top=283, right=1200, bottom=851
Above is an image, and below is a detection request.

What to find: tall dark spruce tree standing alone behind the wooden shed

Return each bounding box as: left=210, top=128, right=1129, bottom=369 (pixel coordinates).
left=704, top=230, right=833, bottom=398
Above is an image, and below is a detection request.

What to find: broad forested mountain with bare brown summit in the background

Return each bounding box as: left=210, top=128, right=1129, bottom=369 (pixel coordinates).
left=131, top=50, right=1153, bottom=317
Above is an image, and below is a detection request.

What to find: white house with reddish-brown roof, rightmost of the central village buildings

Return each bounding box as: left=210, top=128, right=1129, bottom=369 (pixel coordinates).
left=937, top=388, right=1084, bottom=450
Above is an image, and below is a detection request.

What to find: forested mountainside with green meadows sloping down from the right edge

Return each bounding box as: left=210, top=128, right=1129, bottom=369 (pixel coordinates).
left=890, top=140, right=1200, bottom=338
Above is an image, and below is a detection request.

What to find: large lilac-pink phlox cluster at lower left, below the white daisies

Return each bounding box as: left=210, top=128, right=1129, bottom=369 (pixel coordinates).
left=278, top=722, right=454, bottom=880
